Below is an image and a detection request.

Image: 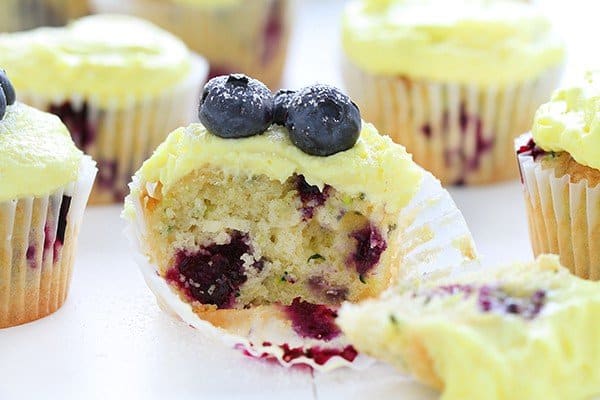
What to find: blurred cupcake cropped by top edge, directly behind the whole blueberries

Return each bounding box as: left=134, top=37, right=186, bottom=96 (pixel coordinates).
left=93, top=0, right=290, bottom=88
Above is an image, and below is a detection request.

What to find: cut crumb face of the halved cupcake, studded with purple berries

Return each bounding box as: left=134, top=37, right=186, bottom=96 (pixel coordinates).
left=142, top=166, right=398, bottom=309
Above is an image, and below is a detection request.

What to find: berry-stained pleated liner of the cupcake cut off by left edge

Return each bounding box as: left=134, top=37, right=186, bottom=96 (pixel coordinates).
left=0, top=156, right=96, bottom=328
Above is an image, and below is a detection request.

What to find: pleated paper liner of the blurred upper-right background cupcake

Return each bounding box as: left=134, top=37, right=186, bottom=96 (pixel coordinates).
left=343, top=60, right=562, bottom=184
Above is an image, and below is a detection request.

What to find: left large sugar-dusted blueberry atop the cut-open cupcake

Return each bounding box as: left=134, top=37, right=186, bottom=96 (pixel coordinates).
left=198, top=74, right=273, bottom=138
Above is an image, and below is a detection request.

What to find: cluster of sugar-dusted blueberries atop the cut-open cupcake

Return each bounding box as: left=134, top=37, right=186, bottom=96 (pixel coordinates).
left=199, top=74, right=361, bottom=156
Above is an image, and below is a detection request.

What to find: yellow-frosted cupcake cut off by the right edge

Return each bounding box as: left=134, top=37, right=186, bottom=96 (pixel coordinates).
left=516, top=72, right=600, bottom=280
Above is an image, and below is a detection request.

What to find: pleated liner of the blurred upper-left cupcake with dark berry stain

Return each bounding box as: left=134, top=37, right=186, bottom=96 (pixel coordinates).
left=19, top=57, right=208, bottom=204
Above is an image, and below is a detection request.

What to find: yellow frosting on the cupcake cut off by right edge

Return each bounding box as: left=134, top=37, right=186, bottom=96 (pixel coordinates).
left=532, top=71, right=600, bottom=169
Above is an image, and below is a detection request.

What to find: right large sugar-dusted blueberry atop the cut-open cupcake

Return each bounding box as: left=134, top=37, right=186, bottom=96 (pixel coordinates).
left=285, top=84, right=361, bottom=156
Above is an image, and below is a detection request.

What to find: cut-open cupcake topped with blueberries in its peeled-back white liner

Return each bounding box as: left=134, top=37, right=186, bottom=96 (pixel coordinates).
left=124, top=75, right=478, bottom=366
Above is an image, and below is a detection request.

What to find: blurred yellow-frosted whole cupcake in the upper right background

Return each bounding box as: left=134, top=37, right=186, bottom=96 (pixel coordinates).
left=342, top=0, right=564, bottom=184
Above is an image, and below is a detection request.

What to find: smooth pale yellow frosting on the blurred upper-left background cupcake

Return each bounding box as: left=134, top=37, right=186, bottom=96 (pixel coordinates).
left=0, top=15, right=191, bottom=105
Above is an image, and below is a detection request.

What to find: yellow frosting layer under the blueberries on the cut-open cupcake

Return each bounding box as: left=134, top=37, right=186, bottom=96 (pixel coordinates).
left=129, top=123, right=423, bottom=211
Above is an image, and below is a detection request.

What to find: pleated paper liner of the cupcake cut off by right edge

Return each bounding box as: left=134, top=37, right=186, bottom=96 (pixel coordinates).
left=515, top=134, right=600, bottom=280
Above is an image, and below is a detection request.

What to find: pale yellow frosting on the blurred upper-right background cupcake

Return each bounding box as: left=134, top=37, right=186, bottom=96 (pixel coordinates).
left=342, top=0, right=564, bottom=86
